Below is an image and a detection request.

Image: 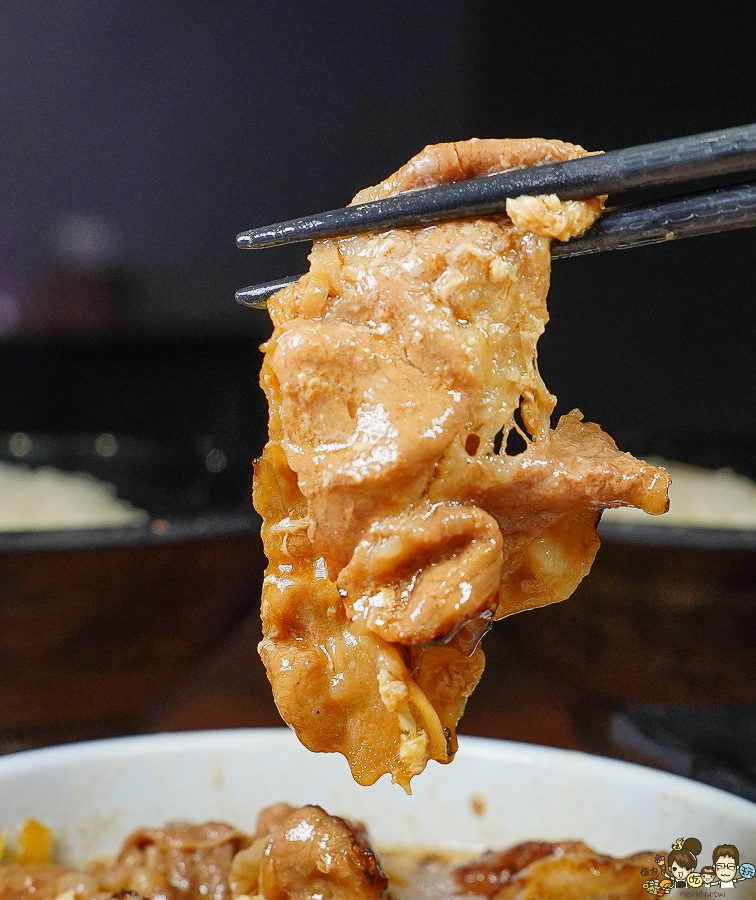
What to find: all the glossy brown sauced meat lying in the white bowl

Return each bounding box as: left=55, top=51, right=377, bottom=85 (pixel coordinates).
left=0, top=816, right=668, bottom=900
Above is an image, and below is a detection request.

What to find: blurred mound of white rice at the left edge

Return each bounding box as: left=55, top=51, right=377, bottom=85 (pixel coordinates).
left=0, top=462, right=150, bottom=531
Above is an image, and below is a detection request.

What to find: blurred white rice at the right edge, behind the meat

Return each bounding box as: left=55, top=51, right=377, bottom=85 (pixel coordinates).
left=602, top=458, right=756, bottom=528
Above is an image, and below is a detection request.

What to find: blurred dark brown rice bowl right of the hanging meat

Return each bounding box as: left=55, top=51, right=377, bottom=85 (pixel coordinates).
left=499, top=450, right=756, bottom=712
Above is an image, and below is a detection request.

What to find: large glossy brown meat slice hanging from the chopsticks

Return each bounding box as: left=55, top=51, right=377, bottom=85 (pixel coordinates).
left=255, top=139, right=668, bottom=787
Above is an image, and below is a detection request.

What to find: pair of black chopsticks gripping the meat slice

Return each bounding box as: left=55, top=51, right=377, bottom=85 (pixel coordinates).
left=236, top=124, right=756, bottom=308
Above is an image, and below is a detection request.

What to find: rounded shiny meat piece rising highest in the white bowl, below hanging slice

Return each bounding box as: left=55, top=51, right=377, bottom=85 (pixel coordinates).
left=260, top=806, right=389, bottom=900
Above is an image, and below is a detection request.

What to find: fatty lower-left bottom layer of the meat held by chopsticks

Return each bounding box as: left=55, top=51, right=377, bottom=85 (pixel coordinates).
left=255, top=443, right=483, bottom=784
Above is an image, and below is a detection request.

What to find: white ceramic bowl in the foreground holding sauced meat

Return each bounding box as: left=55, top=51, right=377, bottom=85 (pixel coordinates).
left=0, top=729, right=756, bottom=864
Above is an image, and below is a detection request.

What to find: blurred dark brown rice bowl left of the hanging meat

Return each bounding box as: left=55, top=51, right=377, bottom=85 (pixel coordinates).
left=0, top=434, right=263, bottom=747
